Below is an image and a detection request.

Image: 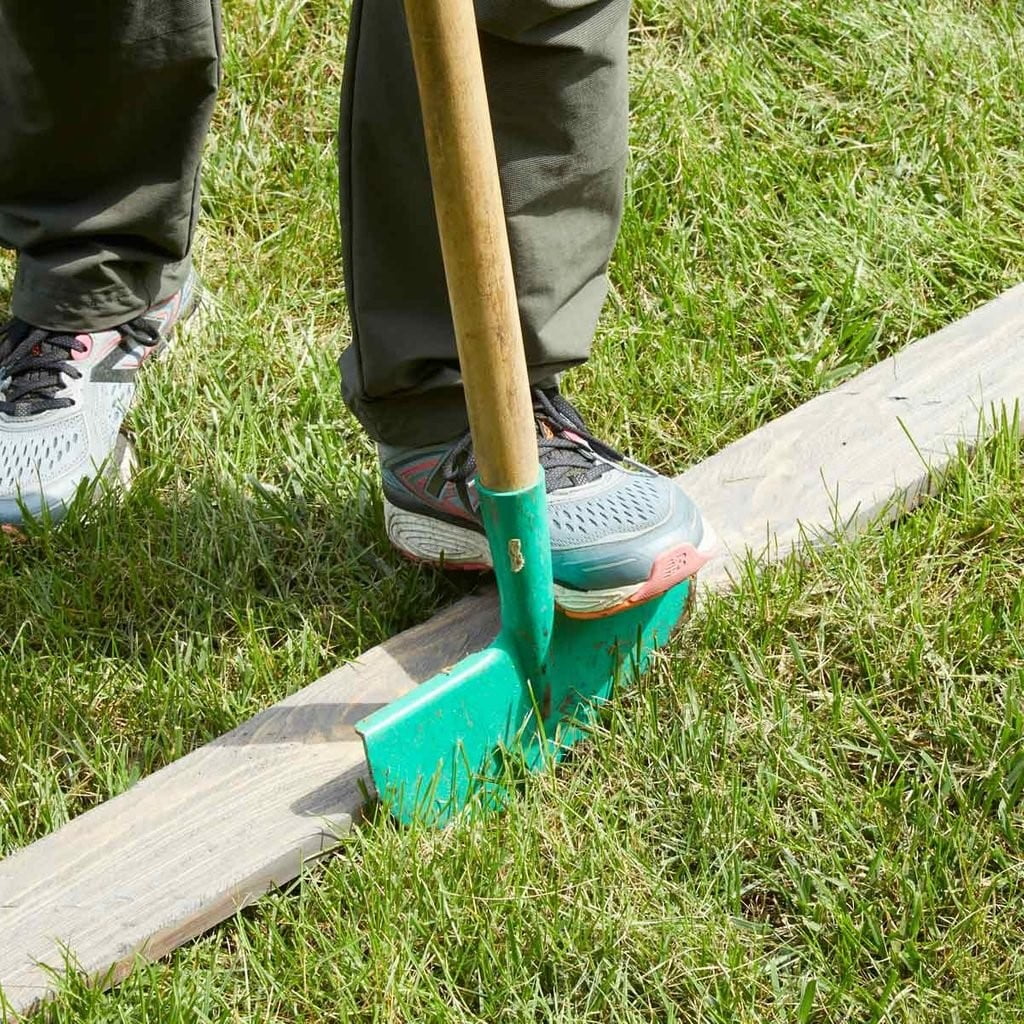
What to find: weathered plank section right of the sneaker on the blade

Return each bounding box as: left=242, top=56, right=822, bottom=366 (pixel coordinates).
left=680, top=285, right=1024, bottom=582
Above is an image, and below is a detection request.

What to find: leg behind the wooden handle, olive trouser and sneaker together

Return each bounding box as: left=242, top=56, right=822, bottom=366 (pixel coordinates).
left=341, top=0, right=714, bottom=616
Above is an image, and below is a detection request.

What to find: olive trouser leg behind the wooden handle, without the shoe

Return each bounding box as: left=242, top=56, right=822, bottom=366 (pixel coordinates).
left=340, top=0, right=629, bottom=444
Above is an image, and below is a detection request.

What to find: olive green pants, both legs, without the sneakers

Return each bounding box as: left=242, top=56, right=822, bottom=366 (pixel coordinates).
left=0, top=0, right=629, bottom=444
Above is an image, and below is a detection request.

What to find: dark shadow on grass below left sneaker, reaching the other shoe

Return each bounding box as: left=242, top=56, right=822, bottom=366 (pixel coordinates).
left=0, top=464, right=479, bottom=660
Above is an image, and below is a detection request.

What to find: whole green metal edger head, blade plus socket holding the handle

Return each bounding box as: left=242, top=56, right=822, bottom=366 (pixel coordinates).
left=356, top=483, right=690, bottom=825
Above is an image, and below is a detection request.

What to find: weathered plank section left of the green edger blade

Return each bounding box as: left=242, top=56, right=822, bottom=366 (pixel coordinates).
left=0, top=597, right=498, bottom=1011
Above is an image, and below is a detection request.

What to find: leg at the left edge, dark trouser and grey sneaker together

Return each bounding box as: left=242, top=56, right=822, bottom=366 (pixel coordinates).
left=0, top=0, right=220, bottom=524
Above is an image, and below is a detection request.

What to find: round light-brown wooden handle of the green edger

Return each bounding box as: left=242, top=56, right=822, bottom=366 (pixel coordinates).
left=403, top=0, right=539, bottom=490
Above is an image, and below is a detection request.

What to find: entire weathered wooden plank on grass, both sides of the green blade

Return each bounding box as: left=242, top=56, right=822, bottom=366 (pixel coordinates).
left=0, top=286, right=1024, bottom=1011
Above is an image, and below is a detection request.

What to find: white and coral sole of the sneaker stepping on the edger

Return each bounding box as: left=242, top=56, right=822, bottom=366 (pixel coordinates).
left=384, top=498, right=718, bottom=618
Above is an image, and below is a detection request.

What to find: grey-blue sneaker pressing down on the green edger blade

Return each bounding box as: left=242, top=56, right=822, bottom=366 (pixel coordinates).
left=380, top=388, right=716, bottom=618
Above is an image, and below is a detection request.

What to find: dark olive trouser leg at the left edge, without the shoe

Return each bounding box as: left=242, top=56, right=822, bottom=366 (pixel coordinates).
left=0, top=0, right=219, bottom=331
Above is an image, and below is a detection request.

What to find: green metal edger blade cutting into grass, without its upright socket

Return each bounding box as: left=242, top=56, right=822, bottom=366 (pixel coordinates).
left=356, top=583, right=689, bottom=825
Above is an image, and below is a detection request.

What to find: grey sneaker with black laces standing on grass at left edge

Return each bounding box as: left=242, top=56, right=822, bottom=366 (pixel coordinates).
left=0, top=274, right=200, bottom=526
